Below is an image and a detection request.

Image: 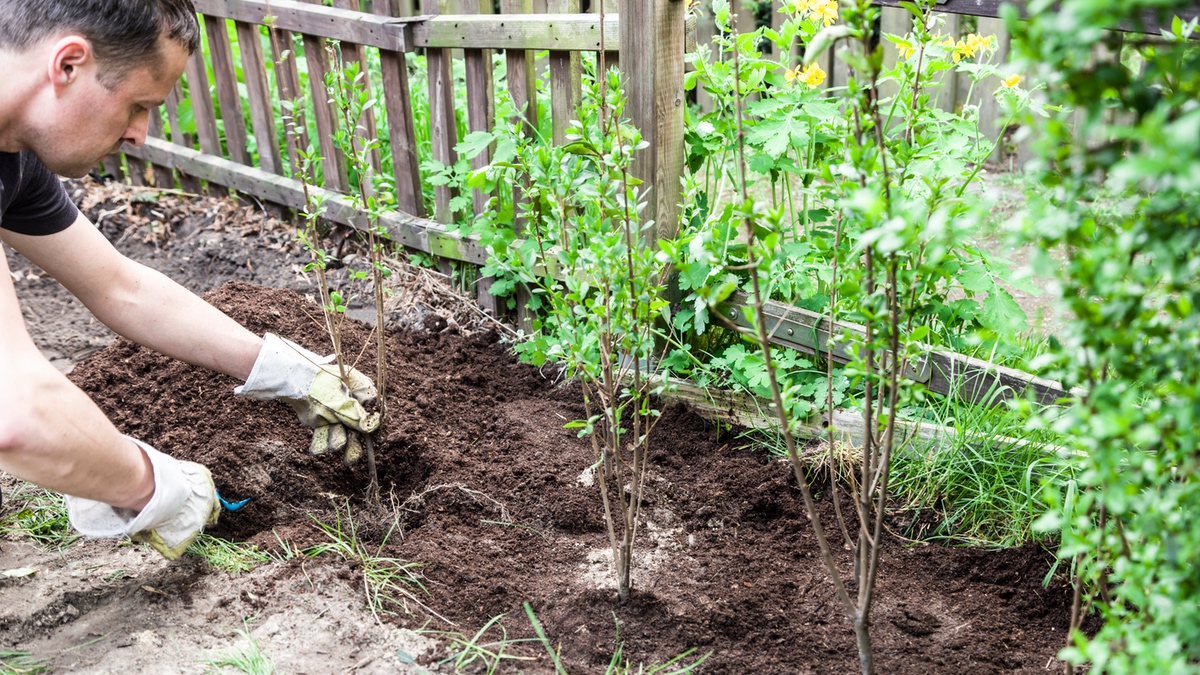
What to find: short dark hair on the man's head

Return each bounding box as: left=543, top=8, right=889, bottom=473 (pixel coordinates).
left=0, top=0, right=200, bottom=86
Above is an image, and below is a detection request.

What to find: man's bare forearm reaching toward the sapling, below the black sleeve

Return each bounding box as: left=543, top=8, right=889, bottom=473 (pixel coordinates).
left=2, top=215, right=263, bottom=380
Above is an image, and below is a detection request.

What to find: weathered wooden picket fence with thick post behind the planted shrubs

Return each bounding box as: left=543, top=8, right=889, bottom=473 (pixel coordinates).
left=106, top=0, right=1064, bottom=402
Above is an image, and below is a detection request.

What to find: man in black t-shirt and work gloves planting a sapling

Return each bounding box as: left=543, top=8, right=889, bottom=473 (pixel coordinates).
left=0, top=0, right=378, bottom=560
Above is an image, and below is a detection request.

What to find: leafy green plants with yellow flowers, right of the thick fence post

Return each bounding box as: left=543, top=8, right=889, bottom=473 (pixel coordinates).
left=660, top=0, right=1032, bottom=419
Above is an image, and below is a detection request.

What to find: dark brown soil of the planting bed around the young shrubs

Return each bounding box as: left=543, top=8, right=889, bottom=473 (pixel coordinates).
left=71, top=282, right=1069, bottom=674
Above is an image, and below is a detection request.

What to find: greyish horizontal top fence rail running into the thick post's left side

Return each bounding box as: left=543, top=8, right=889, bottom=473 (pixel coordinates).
left=413, top=12, right=619, bottom=52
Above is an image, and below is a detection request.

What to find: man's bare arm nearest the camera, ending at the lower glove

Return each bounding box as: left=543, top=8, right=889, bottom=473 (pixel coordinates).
left=0, top=241, right=155, bottom=509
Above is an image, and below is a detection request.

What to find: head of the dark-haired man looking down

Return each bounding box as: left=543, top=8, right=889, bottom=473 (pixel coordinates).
left=0, top=0, right=200, bottom=175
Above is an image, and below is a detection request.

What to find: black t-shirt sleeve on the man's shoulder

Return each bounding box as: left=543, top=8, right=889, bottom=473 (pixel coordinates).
left=0, top=150, right=79, bottom=234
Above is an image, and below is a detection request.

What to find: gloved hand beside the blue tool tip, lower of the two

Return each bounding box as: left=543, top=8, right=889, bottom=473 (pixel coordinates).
left=66, top=436, right=221, bottom=560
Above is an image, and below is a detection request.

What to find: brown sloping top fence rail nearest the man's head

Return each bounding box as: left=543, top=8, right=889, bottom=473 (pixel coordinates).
left=193, top=0, right=413, bottom=52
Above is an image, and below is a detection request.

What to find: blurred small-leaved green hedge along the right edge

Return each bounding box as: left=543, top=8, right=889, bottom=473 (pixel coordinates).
left=1008, top=0, right=1200, bottom=673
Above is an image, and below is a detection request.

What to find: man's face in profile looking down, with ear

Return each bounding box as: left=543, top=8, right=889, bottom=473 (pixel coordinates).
left=31, top=40, right=187, bottom=178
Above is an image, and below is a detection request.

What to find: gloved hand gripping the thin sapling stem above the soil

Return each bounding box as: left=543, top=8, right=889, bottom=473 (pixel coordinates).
left=233, top=333, right=379, bottom=465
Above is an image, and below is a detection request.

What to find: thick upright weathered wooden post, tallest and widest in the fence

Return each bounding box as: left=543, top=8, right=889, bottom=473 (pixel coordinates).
left=620, top=0, right=686, bottom=240
